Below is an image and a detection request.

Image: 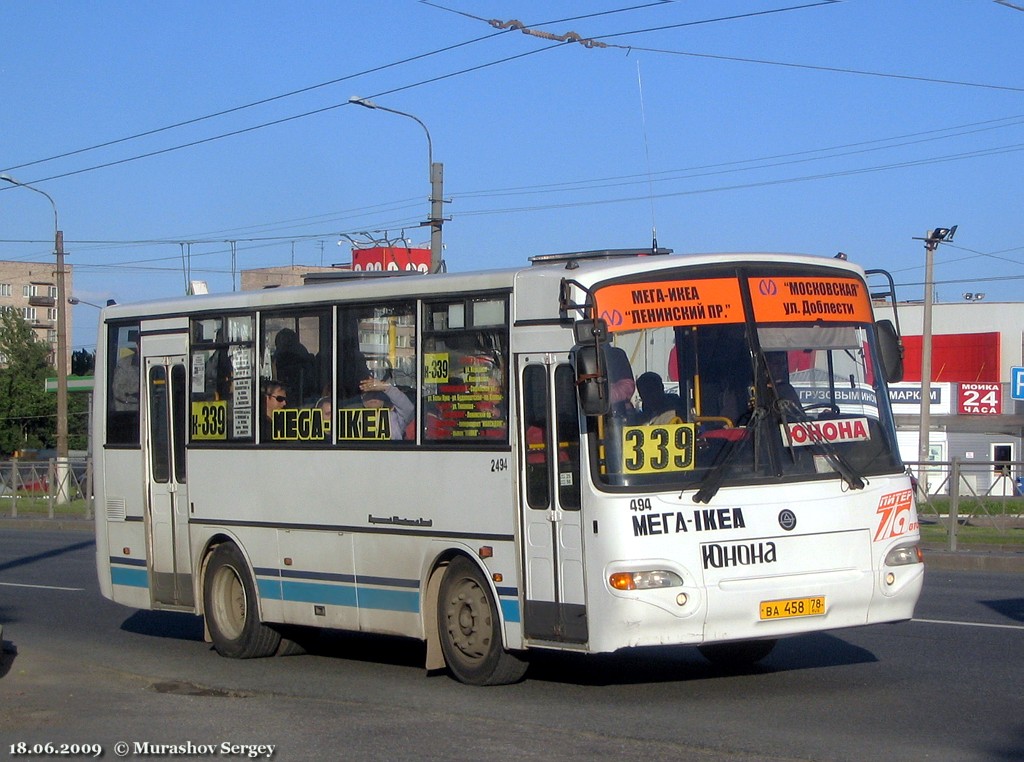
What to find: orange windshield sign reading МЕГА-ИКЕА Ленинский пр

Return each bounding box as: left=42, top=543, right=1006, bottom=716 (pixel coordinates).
left=596, top=278, right=743, bottom=331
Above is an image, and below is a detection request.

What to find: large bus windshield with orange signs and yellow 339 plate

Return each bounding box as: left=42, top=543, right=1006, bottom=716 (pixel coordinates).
left=590, top=266, right=902, bottom=493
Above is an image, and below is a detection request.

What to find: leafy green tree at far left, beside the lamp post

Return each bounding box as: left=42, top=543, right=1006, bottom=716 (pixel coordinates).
left=0, top=309, right=57, bottom=454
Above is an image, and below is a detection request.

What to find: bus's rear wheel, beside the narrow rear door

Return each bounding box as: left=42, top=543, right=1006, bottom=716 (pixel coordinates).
left=203, top=543, right=281, bottom=659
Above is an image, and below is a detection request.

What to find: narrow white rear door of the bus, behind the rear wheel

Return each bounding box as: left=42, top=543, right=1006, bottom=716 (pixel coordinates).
left=142, top=350, right=196, bottom=608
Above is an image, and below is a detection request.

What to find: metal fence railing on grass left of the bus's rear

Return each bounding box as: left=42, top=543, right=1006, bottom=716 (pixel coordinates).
left=0, top=458, right=93, bottom=518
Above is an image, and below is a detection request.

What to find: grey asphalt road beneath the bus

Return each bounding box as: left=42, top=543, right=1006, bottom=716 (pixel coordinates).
left=0, top=525, right=1024, bottom=761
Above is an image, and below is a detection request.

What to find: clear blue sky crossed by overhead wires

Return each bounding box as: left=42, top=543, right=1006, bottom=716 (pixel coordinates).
left=0, top=0, right=1024, bottom=349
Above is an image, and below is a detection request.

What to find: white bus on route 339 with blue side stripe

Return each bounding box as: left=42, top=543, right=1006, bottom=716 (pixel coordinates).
left=93, top=251, right=924, bottom=684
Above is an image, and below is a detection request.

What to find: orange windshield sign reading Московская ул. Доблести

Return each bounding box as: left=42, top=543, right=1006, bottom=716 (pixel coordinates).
left=749, top=276, right=871, bottom=323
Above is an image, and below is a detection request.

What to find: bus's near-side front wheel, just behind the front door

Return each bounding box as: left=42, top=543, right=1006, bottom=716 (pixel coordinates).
left=437, top=556, right=527, bottom=685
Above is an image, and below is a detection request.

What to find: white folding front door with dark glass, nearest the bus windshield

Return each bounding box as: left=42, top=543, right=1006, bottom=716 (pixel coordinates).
left=518, top=354, right=588, bottom=643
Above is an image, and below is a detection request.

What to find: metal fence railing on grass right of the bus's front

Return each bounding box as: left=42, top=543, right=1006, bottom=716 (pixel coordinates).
left=906, top=458, right=1024, bottom=551
